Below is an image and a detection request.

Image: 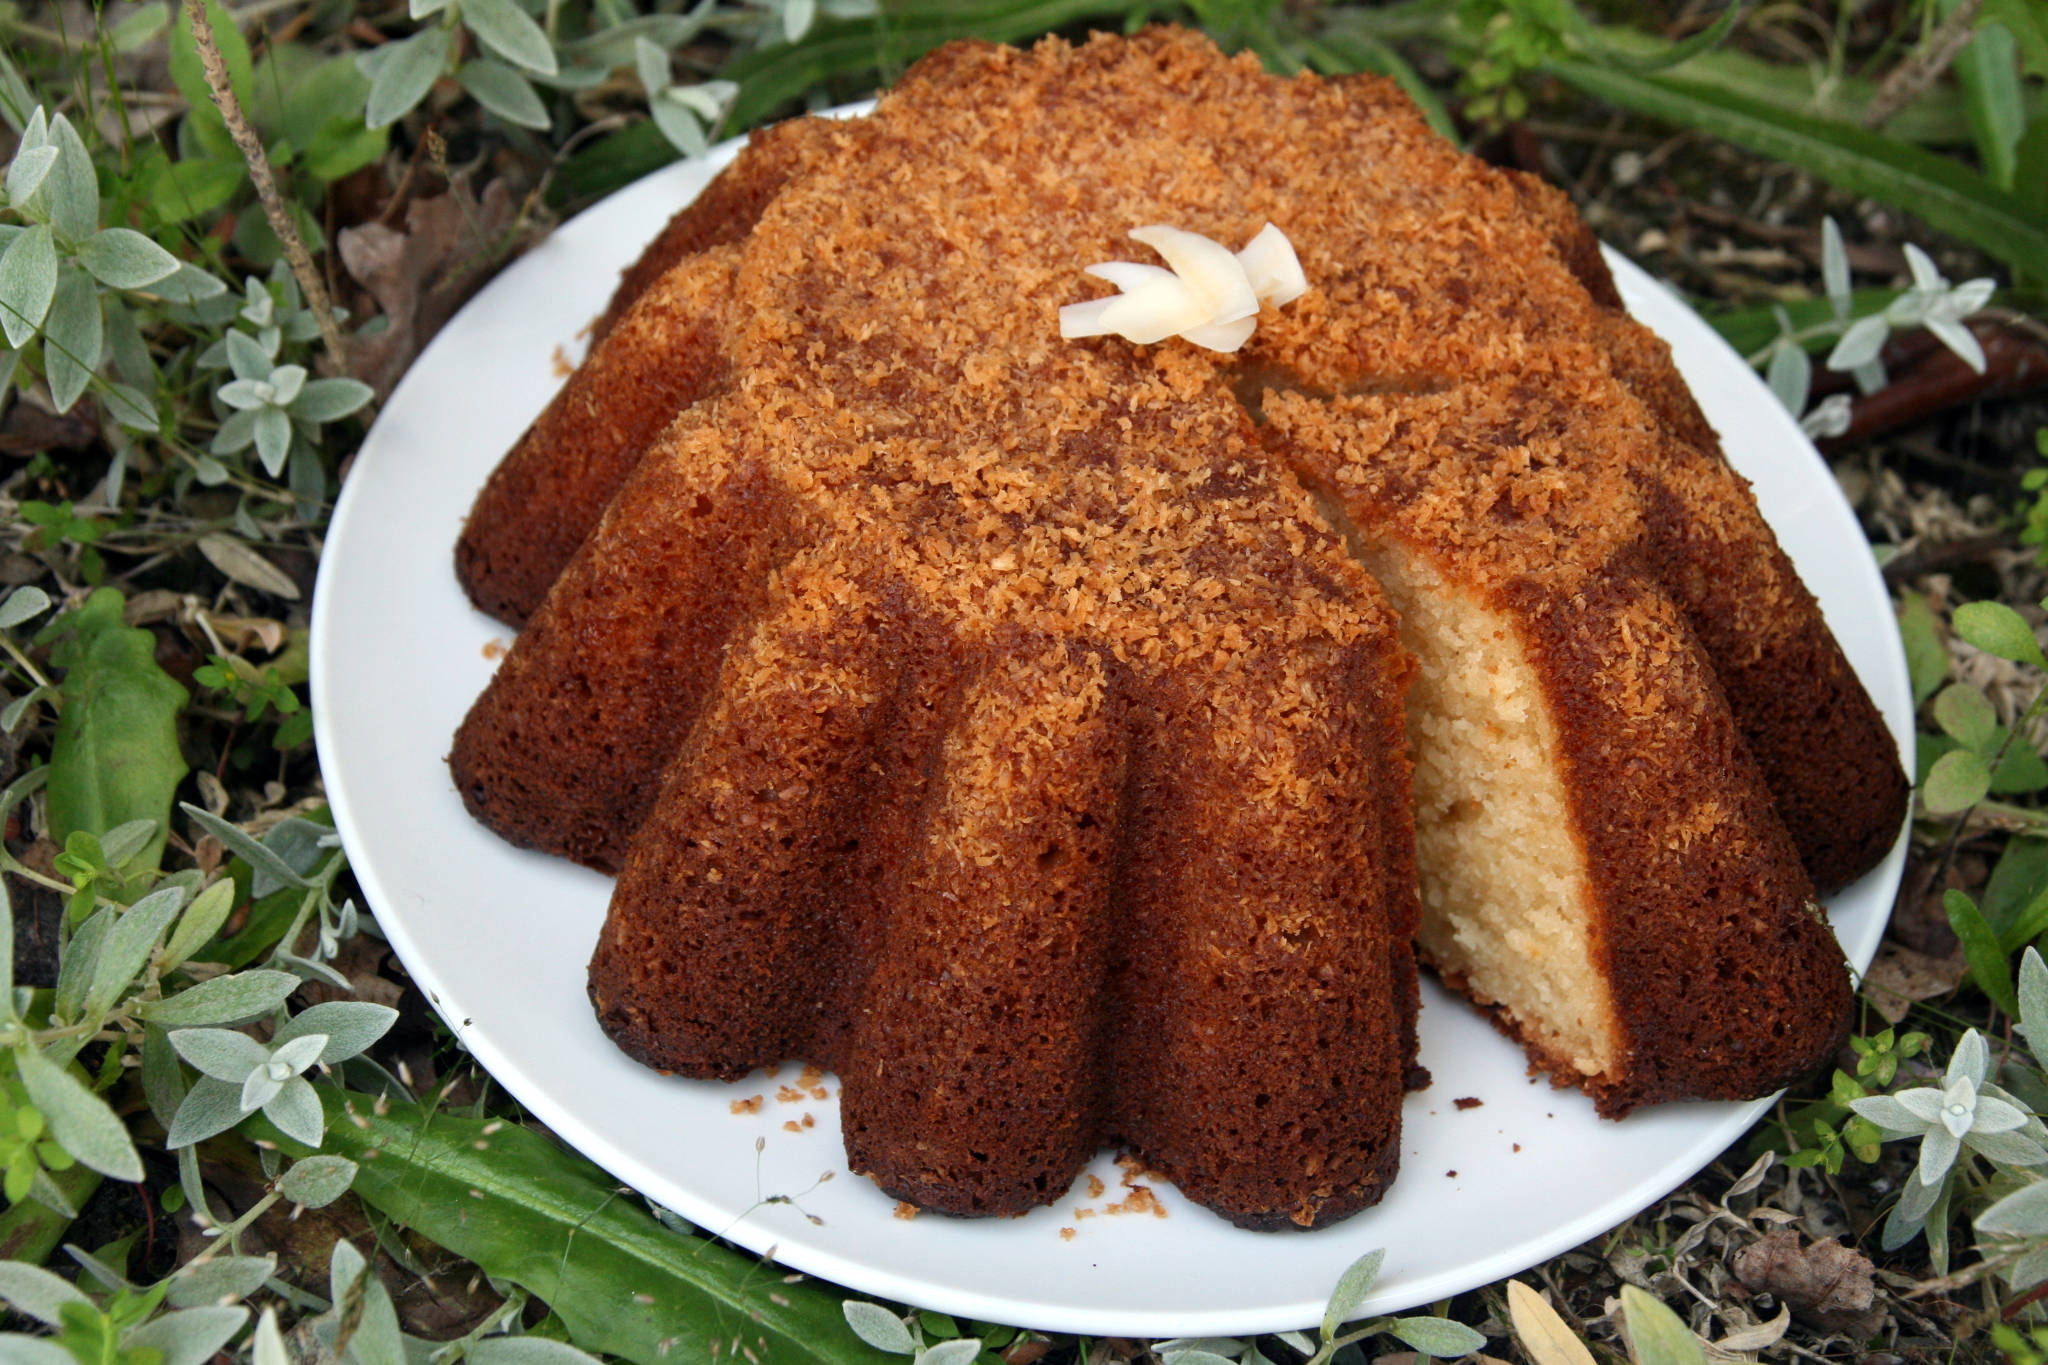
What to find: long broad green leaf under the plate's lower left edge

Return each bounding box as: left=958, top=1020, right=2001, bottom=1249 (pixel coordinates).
left=299, top=1089, right=889, bottom=1365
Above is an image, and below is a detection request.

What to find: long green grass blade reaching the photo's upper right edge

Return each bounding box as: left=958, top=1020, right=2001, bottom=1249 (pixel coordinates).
left=1550, top=61, right=2048, bottom=278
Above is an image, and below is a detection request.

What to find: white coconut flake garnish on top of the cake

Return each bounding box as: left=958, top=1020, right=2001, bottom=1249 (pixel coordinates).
left=1059, top=223, right=1309, bottom=352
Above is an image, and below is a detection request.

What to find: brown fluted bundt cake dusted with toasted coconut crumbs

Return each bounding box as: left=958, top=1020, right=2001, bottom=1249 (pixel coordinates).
left=451, top=31, right=1907, bottom=1228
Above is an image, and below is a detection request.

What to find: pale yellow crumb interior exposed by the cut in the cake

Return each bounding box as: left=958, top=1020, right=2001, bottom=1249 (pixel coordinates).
left=1352, top=536, right=1620, bottom=1078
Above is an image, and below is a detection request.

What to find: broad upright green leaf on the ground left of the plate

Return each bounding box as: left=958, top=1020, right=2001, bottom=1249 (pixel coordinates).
left=37, top=587, right=186, bottom=874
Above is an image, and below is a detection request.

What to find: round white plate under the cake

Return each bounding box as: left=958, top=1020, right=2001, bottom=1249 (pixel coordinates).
left=313, top=112, right=1913, bottom=1336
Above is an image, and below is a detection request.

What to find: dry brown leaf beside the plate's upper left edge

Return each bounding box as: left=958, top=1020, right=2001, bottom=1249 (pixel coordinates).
left=336, top=176, right=514, bottom=392
